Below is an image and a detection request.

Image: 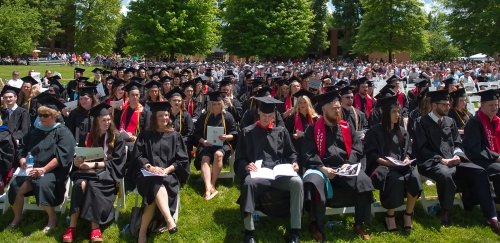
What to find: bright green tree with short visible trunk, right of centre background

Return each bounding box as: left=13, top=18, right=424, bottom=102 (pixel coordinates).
left=353, top=0, right=429, bottom=62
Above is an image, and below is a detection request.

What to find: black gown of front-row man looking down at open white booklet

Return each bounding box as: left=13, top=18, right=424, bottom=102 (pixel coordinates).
left=234, top=124, right=297, bottom=215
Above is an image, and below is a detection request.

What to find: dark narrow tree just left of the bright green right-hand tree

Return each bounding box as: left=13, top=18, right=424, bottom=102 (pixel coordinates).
left=332, top=0, right=363, bottom=56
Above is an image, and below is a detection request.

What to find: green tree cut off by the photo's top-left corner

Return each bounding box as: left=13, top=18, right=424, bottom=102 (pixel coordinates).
left=0, top=1, right=42, bottom=56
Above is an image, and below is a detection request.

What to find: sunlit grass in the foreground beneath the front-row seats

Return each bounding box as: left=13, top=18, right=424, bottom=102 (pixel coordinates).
left=0, top=162, right=500, bottom=243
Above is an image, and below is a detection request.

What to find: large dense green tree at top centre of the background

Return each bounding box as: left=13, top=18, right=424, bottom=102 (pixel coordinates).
left=221, top=0, right=314, bottom=58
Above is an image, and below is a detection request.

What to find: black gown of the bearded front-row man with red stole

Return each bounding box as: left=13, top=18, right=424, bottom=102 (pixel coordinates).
left=301, top=125, right=374, bottom=228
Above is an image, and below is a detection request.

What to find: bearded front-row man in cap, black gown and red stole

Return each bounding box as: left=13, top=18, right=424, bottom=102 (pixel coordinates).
left=301, top=92, right=374, bottom=241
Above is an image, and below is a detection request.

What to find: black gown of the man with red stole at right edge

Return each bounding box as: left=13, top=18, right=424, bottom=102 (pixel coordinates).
left=463, top=115, right=500, bottom=203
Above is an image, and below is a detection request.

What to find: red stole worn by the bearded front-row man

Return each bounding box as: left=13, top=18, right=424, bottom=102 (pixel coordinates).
left=314, top=117, right=352, bottom=160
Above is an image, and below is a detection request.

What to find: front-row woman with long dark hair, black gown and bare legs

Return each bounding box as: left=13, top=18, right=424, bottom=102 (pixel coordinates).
left=364, top=96, right=422, bottom=232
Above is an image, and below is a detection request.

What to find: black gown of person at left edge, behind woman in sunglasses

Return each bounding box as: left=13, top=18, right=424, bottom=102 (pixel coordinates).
left=2, top=107, right=30, bottom=141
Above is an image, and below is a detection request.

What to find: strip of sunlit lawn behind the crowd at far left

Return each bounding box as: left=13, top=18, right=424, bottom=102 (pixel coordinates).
left=0, top=64, right=103, bottom=83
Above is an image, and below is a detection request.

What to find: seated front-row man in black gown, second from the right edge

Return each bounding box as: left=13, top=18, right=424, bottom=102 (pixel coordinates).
left=414, top=90, right=497, bottom=226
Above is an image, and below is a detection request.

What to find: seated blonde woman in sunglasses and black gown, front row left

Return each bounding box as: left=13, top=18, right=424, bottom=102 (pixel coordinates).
left=8, top=96, right=75, bottom=232
